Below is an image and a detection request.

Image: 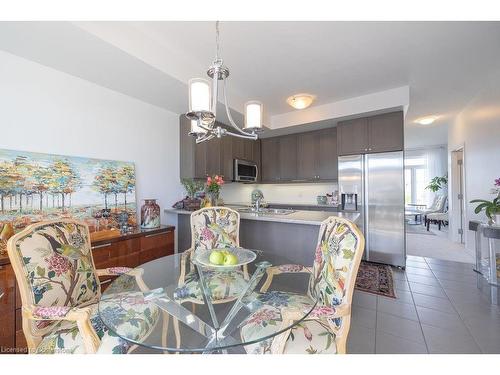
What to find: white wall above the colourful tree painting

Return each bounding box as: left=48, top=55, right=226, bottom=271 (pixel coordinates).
left=0, top=51, right=182, bottom=224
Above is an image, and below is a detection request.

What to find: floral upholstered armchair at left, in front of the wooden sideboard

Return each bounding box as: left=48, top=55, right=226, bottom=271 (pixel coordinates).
left=7, top=219, right=158, bottom=353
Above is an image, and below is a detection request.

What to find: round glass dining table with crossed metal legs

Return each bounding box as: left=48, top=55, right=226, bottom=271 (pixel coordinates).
left=98, top=250, right=317, bottom=353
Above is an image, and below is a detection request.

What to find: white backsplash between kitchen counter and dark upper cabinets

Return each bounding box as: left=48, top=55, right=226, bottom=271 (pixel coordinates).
left=221, top=182, right=338, bottom=204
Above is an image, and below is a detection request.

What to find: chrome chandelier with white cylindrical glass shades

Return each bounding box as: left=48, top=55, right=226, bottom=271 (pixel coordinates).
left=186, top=21, right=262, bottom=143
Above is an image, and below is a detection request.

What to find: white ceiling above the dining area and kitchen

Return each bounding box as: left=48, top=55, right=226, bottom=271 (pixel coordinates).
left=0, top=22, right=500, bottom=148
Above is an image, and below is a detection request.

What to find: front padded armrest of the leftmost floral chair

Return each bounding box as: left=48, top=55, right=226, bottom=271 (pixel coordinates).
left=23, top=306, right=101, bottom=353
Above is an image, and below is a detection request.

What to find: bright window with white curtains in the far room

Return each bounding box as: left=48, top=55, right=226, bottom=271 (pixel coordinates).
left=405, top=146, right=448, bottom=206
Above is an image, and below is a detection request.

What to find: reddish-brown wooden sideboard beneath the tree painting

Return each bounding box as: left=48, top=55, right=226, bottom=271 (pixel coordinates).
left=0, top=226, right=175, bottom=354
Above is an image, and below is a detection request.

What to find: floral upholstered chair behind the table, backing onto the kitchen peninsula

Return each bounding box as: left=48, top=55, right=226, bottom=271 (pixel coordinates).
left=174, top=207, right=248, bottom=304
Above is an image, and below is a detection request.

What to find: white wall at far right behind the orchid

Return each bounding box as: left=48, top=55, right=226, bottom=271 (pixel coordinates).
left=448, top=72, right=500, bottom=250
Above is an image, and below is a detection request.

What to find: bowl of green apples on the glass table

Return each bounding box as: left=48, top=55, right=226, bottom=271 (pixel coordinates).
left=195, top=247, right=257, bottom=269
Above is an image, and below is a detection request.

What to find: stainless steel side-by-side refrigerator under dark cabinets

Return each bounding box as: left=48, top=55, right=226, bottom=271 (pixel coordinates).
left=339, top=151, right=406, bottom=267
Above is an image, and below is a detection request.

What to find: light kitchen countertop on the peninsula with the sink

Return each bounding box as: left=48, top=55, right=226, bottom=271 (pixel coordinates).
left=165, top=208, right=360, bottom=225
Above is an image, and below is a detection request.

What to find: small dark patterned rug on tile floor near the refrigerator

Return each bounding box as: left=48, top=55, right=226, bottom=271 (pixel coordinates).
left=355, top=261, right=396, bottom=298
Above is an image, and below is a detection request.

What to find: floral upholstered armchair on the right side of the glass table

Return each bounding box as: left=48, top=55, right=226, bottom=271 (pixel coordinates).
left=241, top=216, right=365, bottom=354
